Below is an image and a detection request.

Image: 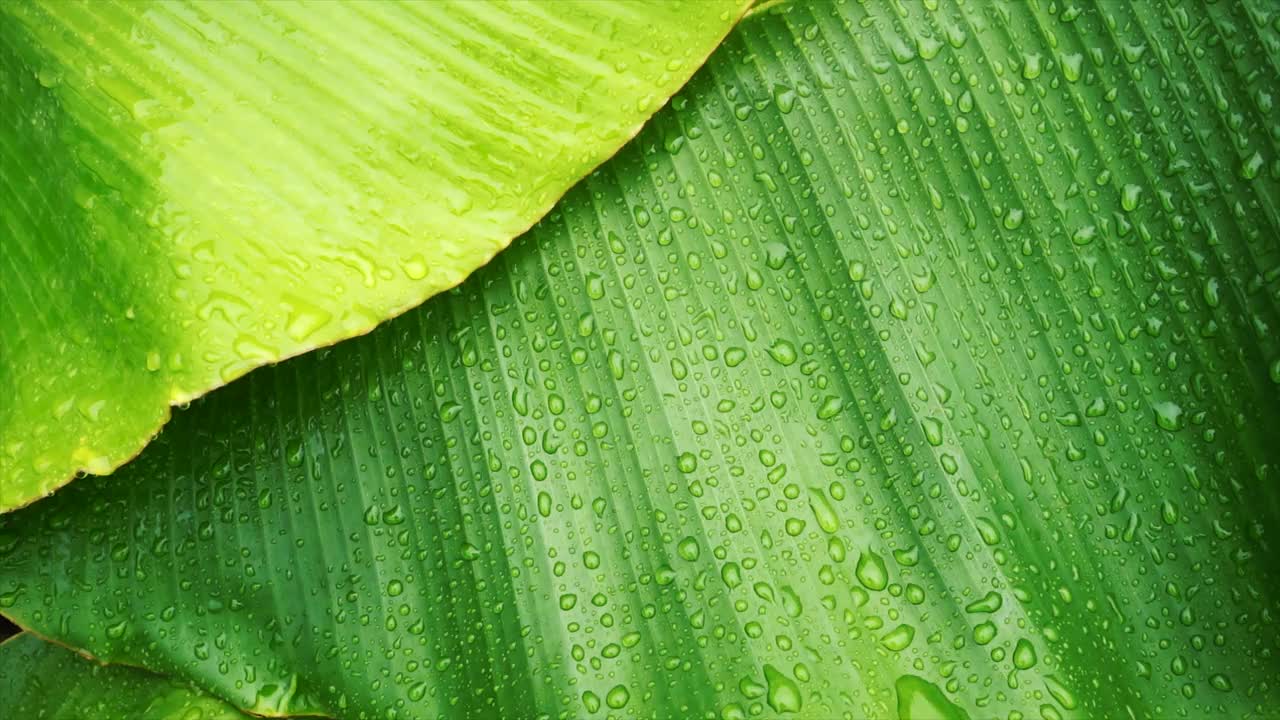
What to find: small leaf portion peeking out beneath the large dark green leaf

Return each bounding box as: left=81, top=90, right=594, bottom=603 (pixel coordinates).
left=0, top=633, right=251, bottom=720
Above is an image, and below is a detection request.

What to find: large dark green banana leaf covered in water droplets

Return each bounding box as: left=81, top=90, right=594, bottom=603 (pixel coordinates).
left=0, top=1, right=1280, bottom=720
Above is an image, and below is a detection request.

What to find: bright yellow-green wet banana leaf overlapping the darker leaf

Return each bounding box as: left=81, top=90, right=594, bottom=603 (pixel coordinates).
left=0, top=0, right=748, bottom=512
